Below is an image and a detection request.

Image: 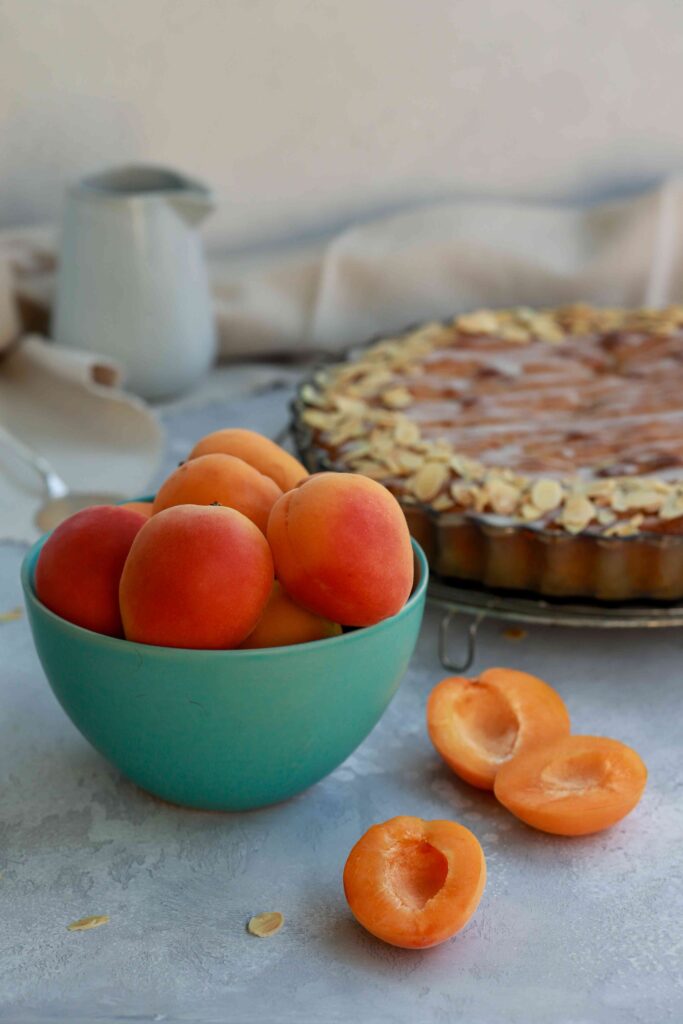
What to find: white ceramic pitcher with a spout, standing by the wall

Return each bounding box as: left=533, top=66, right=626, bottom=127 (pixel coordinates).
left=53, top=166, right=216, bottom=398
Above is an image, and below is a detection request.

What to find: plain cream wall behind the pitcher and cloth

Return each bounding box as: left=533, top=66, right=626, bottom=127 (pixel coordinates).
left=0, top=0, right=683, bottom=245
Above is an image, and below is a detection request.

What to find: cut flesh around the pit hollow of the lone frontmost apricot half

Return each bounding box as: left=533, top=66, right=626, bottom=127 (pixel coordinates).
left=343, top=816, right=486, bottom=949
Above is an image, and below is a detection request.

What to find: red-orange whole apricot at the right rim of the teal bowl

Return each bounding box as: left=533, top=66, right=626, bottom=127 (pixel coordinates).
left=267, top=473, right=413, bottom=626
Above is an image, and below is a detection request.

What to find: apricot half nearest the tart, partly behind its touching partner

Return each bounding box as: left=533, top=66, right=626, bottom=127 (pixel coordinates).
left=427, top=669, right=571, bottom=790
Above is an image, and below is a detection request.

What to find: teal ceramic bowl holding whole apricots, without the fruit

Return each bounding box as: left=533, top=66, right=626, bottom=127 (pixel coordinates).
left=22, top=524, right=429, bottom=811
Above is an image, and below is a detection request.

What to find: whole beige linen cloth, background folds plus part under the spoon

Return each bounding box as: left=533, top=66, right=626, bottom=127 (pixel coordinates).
left=0, top=179, right=683, bottom=536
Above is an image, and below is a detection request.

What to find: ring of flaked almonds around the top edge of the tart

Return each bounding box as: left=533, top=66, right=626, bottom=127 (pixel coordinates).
left=301, top=303, right=683, bottom=540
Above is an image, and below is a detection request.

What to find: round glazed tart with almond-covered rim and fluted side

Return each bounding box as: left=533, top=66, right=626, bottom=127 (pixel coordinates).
left=295, top=305, right=683, bottom=600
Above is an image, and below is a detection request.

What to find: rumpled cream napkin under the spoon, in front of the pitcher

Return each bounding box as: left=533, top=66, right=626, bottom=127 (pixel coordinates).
left=0, top=242, right=163, bottom=541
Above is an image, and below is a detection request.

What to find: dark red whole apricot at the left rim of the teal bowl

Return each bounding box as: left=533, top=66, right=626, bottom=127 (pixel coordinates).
left=35, top=505, right=146, bottom=637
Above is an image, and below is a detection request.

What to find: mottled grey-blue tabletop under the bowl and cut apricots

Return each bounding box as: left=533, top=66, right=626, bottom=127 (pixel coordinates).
left=0, top=382, right=683, bottom=1024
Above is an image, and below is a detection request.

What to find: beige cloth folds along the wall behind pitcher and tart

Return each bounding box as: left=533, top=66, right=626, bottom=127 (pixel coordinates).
left=7, top=180, right=683, bottom=358
